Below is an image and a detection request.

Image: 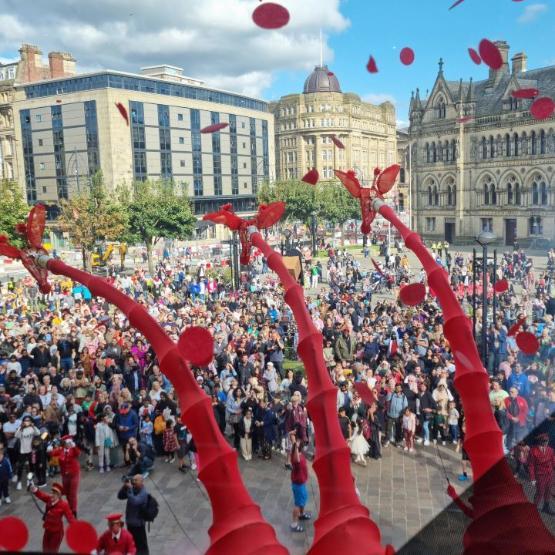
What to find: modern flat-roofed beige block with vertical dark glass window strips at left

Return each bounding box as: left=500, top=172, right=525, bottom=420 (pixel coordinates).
left=14, top=66, right=274, bottom=217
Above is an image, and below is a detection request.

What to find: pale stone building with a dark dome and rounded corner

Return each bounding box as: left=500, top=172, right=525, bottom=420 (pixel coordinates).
left=270, top=65, right=396, bottom=184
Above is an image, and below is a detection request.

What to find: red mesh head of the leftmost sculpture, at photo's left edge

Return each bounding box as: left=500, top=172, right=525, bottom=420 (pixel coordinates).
left=0, top=204, right=50, bottom=294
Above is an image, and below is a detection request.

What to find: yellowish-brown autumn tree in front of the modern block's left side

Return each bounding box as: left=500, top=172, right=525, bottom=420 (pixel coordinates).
left=58, top=172, right=127, bottom=270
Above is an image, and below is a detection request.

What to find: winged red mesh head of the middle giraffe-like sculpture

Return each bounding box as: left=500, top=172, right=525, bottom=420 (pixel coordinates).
left=202, top=202, right=285, bottom=266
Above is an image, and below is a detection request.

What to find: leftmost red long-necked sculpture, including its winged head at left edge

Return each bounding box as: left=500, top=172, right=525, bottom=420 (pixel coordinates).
left=0, top=205, right=288, bottom=555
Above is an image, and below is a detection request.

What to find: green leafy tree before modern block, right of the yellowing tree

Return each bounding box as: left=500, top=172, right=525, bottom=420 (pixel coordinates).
left=123, top=180, right=196, bottom=274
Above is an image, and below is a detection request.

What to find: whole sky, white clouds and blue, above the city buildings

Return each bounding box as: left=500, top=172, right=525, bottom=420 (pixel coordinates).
left=0, top=0, right=555, bottom=126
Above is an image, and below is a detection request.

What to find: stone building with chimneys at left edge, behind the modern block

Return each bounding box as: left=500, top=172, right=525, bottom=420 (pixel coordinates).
left=0, top=44, right=75, bottom=181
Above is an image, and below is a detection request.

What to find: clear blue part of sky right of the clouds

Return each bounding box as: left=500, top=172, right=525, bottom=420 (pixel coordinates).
left=265, top=0, right=555, bottom=126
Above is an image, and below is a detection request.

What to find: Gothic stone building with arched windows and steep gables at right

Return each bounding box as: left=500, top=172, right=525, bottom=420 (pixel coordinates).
left=409, top=41, right=555, bottom=246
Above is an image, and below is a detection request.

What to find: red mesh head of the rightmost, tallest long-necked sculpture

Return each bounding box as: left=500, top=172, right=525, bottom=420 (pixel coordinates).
left=335, top=164, right=401, bottom=235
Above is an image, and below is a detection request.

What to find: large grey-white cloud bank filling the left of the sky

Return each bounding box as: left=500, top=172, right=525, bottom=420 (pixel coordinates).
left=0, top=0, right=349, bottom=96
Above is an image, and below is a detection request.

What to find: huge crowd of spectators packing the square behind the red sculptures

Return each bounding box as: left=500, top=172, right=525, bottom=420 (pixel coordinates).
left=0, top=239, right=555, bottom=553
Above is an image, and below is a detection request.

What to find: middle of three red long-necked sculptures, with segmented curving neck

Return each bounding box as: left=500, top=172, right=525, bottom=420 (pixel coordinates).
left=205, top=205, right=394, bottom=555
